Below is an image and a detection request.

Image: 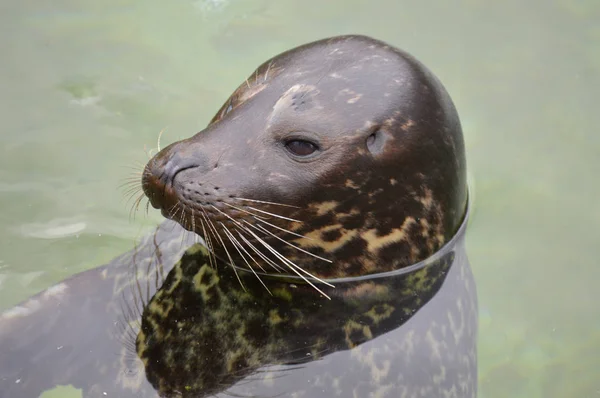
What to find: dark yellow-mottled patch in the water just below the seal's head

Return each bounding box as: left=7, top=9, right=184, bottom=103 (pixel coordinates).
left=137, top=244, right=449, bottom=396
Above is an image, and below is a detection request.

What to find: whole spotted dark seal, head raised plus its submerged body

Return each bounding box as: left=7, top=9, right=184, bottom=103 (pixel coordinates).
left=0, top=35, right=477, bottom=397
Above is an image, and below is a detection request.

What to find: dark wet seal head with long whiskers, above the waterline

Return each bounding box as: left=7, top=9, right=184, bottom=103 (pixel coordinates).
left=142, top=36, right=467, bottom=278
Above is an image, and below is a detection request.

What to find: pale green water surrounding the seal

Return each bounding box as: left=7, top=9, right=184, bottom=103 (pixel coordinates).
left=0, top=0, right=600, bottom=398
